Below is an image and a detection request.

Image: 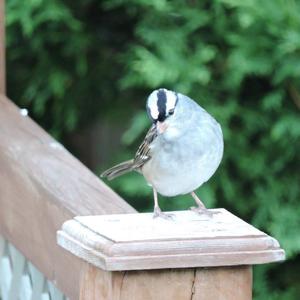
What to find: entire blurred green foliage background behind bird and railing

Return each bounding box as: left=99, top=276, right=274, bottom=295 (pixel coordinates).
left=6, top=0, right=300, bottom=300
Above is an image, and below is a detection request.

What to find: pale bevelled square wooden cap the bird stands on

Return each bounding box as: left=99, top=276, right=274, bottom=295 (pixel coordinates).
left=57, top=209, right=285, bottom=271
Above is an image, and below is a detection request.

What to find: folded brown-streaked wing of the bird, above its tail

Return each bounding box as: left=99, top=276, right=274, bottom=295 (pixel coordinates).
left=134, top=124, right=157, bottom=169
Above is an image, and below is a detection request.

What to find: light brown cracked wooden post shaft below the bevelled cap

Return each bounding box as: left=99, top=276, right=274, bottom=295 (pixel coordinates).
left=80, top=265, right=252, bottom=300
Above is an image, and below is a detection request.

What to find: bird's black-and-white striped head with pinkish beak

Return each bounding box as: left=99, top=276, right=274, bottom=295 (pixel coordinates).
left=146, top=88, right=178, bottom=134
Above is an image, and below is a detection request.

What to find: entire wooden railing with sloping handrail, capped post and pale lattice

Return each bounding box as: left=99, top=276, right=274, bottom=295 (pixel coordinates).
left=0, top=0, right=284, bottom=300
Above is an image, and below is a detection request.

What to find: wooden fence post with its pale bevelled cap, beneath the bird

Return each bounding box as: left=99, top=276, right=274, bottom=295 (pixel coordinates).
left=57, top=209, right=284, bottom=300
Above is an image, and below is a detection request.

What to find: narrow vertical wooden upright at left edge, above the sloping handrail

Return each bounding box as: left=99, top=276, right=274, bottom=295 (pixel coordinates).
left=0, top=0, right=5, bottom=94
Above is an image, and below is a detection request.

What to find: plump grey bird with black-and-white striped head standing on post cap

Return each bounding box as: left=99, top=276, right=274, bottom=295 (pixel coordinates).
left=101, top=88, right=224, bottom=218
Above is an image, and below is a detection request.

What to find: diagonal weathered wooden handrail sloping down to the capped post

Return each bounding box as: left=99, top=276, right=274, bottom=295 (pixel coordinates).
left=0, top=95, right=134, bottom=300
